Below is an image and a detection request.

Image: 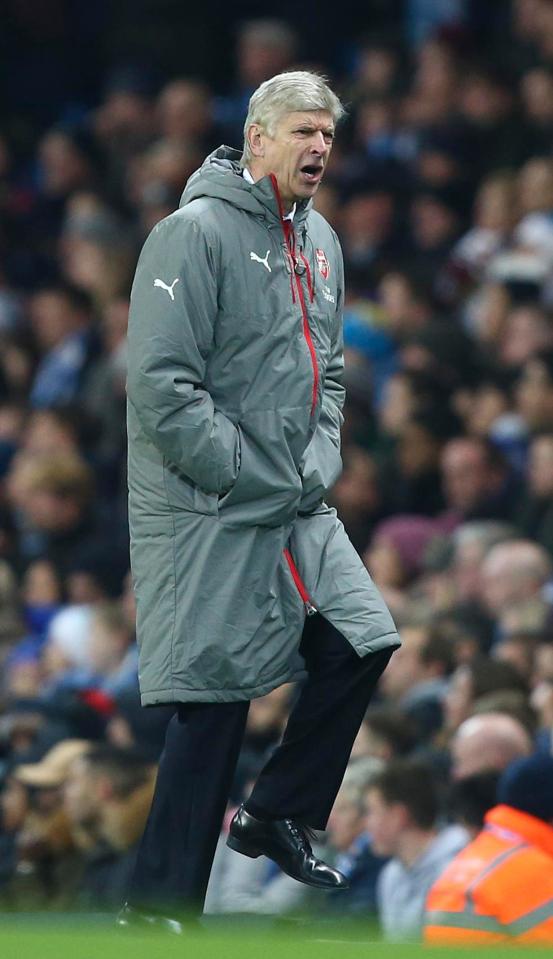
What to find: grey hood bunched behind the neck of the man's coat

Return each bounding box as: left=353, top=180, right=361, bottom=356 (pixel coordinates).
left=179, top=146, right=312, bottom=224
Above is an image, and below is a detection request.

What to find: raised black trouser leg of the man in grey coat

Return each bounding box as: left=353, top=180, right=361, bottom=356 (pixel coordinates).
left=245, top=617, right=393, bottom=829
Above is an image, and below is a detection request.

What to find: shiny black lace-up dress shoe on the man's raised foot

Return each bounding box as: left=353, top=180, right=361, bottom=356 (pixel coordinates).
left=227, top=806, right=349, bottom=889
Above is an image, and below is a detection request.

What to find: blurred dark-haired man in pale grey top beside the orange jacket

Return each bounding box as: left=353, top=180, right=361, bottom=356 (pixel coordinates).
left=366, top=759, right=469, bottom=942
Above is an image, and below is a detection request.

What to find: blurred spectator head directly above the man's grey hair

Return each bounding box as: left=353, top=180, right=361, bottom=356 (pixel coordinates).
left=237, top=18, right=298, bottom=88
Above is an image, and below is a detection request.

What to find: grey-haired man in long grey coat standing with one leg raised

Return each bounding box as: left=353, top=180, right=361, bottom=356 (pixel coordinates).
left=120, top=72, right=399, bottom=928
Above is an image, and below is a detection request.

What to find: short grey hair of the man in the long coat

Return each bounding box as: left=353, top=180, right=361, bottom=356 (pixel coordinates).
left=240, top=70, right=346, bottom=167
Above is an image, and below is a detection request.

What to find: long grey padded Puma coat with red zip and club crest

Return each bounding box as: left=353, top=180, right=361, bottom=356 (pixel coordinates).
left=128, top=147, right=399, bottom=705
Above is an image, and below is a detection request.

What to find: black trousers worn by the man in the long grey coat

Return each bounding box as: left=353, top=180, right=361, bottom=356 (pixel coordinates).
left=128, top=617, right=392, bottom=913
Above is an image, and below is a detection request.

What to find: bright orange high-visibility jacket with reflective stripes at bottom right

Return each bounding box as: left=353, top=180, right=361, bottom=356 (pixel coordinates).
left=424, top=806, right=553, bottom=945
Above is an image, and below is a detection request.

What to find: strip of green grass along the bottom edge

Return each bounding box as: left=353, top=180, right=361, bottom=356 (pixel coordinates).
left=0, top=916, right=551, bottom=959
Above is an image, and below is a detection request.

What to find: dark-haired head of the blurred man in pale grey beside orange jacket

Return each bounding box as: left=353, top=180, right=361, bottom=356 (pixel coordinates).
left=366, top=759, right=438, bottom=856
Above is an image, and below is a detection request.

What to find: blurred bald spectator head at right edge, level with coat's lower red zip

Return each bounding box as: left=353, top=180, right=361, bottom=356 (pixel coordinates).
left=481, top=540, right=553, bottom=616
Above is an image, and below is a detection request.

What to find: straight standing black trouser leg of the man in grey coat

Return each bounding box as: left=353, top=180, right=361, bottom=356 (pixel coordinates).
left=128, top=702, right=249, bottom=915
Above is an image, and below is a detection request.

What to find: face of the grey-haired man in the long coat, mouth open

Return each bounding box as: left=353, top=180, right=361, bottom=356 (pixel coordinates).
left=250, top=110, right=334, bottom=208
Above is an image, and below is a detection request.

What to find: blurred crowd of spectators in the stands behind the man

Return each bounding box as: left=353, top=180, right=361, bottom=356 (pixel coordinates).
left=0, top=0, right=553, bottom=938
